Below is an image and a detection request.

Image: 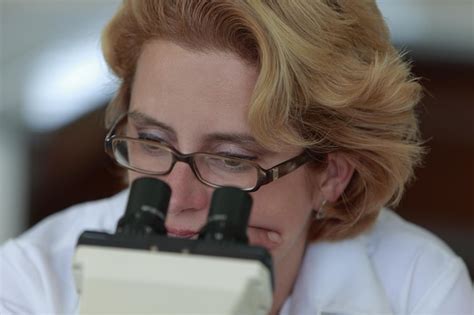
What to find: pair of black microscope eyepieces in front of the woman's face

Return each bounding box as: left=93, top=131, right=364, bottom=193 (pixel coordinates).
left=116, top=177, right=252, bottom=244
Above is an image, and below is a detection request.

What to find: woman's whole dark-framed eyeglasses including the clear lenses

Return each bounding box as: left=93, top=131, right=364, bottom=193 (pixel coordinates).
left=105, top=113, right=324, bottom=192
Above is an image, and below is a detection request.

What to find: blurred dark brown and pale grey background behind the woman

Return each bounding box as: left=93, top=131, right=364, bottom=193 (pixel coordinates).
left=0, top=0, right=474, bottom=277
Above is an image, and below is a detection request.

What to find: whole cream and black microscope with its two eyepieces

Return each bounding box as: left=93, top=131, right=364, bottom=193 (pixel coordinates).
left=73, top=177, right=273, bottom=315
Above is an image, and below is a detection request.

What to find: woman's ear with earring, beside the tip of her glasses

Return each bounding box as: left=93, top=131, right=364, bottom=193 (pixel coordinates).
left=315, top=152, right=354, bottom=205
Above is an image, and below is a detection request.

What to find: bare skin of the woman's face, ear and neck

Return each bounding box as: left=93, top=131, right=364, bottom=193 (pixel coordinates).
left=129, top=40, right=352, bottom=314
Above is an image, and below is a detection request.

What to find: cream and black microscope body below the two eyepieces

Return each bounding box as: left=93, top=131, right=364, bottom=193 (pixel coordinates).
left=73, top=181, right=273, bottom=315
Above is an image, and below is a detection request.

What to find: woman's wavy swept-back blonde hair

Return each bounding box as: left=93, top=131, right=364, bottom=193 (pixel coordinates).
left=103, top=0, right=422, bottom=240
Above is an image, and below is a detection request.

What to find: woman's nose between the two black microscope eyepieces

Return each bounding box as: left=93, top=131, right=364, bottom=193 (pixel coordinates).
left=162, top=162, right=211, bottom=220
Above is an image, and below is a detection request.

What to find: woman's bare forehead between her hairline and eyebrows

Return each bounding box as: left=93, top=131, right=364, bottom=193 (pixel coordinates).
left=130, top=40, right=258, bottom=144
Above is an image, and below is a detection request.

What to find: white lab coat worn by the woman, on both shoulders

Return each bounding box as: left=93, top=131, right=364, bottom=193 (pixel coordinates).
left=0, top=191, right=474, bottom=315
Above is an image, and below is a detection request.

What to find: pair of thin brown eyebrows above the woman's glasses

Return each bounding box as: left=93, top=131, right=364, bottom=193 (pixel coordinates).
left=129, top=111, right=268, bottom=154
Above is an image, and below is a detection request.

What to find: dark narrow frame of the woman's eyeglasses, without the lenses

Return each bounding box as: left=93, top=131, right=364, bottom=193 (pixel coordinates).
left=104, top=112, right=322, bottom=192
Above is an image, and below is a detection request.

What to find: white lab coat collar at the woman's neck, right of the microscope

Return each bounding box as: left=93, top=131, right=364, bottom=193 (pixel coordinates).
left=282, top=235, right=393, bottom=315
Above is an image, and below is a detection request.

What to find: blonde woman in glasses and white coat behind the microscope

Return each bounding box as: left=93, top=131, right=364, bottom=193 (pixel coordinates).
left=0, top=0, right=473, bottom=314
